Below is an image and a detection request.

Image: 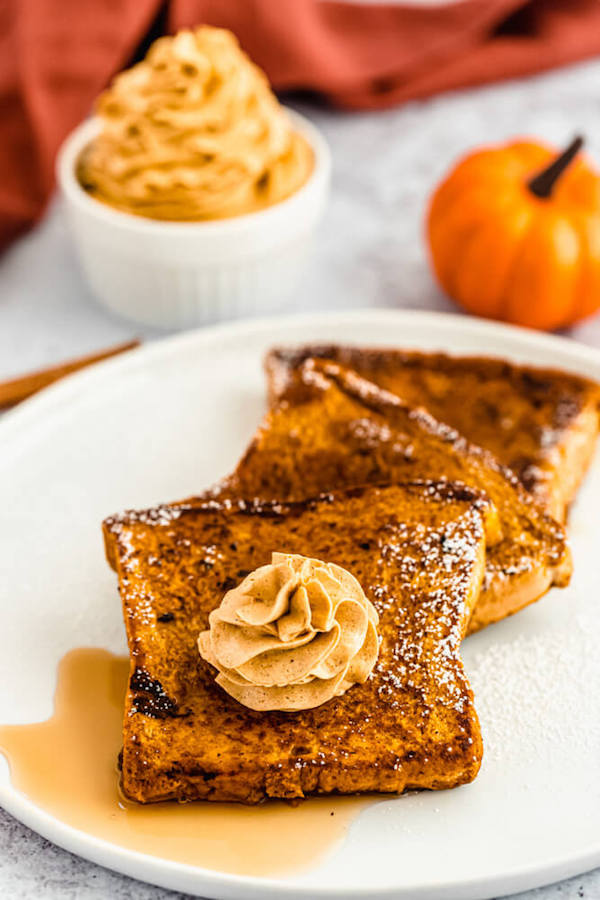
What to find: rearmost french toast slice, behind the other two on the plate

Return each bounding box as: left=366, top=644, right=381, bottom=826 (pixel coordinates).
left=265, top=344, right=600, bottom=520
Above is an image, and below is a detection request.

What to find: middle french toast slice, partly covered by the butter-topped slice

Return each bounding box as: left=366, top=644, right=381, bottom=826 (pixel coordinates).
left=216, top=360, right=571, bottom=632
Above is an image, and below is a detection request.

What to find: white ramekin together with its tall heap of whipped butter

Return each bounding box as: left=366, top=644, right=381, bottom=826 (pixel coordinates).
left=57, top=26, right=330, bottom=328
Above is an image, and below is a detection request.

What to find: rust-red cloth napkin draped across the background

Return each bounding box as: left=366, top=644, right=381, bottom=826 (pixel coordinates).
left=0, top=0, right=600, bottom=248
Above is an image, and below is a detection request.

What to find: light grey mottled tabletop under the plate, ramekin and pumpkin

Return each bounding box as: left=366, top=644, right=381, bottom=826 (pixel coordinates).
left=0, top=54, right=600, bottom=900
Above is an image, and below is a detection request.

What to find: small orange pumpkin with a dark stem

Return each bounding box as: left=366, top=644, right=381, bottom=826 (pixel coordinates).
left=427, top=138, right=600, bottom=330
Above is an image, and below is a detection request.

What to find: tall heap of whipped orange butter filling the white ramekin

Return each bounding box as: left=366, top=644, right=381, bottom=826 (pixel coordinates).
left=77, top=26, right=313, bottom=221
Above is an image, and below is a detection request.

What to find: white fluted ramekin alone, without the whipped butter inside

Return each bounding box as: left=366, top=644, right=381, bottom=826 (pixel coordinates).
left=57, top=110, right=331, bottom=328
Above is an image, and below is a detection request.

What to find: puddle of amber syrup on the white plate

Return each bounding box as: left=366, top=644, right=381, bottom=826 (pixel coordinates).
left=0, top=648, right=373, bottom=875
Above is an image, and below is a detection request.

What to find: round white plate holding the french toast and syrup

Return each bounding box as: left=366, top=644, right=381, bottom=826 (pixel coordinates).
left=0, top=311, right=600, bottom=898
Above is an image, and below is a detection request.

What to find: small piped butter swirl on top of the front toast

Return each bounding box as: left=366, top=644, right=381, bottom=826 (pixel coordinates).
left=198, top=553, right=379, bottom=711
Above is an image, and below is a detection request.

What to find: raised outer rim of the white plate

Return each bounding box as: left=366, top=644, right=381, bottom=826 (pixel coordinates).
left=0, top=309, right=600, bottom=900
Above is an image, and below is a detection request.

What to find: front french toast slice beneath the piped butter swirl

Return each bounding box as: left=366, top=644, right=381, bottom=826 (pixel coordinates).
left=104, top=482, right=497, bottom=803
